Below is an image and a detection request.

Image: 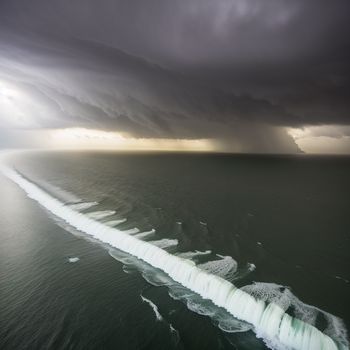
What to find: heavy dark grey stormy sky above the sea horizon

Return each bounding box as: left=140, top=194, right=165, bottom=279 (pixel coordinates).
left=0, top=0, right=350, bottom=153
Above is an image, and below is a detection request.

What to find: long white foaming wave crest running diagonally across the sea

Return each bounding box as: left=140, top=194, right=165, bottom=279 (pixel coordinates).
left=2, top=168, right=348, bottom=350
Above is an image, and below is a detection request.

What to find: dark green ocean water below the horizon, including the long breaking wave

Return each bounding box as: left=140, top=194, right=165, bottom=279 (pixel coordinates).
left=0, top=152, right=350, bottom=350
